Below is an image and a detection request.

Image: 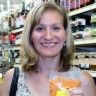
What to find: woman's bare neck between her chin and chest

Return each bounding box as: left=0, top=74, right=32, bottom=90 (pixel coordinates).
left=38, top=56, right=60, bottom=75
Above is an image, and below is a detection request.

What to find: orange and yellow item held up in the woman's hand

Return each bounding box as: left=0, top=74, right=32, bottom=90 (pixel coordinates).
left=49, top=76, right=81, bottom=96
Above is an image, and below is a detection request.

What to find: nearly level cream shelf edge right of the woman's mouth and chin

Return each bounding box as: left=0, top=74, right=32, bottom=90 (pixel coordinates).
left=74, top=37, right=96, bottom=45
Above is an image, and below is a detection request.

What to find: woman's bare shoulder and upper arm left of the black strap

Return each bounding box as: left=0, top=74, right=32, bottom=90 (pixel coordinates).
left=2, top=68, right=14, bottom=96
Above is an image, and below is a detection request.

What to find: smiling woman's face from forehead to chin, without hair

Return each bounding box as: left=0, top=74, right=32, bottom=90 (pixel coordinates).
left=31, top=11, right=66, bottom=58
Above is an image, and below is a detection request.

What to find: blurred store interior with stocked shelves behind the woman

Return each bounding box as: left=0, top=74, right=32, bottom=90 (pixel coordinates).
left=0, top=0, right=96, bottom=82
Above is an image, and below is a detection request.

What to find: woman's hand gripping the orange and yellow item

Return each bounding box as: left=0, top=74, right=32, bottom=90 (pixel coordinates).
left=69, top=88, right=84, bottom=96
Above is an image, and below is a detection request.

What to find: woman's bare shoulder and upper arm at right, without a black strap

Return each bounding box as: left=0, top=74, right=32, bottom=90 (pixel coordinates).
left=81, top=71, right=96, bottom=96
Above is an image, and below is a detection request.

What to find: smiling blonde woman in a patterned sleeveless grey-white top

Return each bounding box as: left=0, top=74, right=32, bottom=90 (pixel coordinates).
left=2, top=2, right=96, bottom=96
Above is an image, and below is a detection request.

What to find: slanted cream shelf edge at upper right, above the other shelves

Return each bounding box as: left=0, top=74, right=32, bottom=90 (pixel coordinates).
left=68, top=3, right=96, bottom=16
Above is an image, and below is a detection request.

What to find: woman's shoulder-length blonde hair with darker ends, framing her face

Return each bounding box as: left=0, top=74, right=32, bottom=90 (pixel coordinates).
left=21, top=2, right=73, bottom=71
